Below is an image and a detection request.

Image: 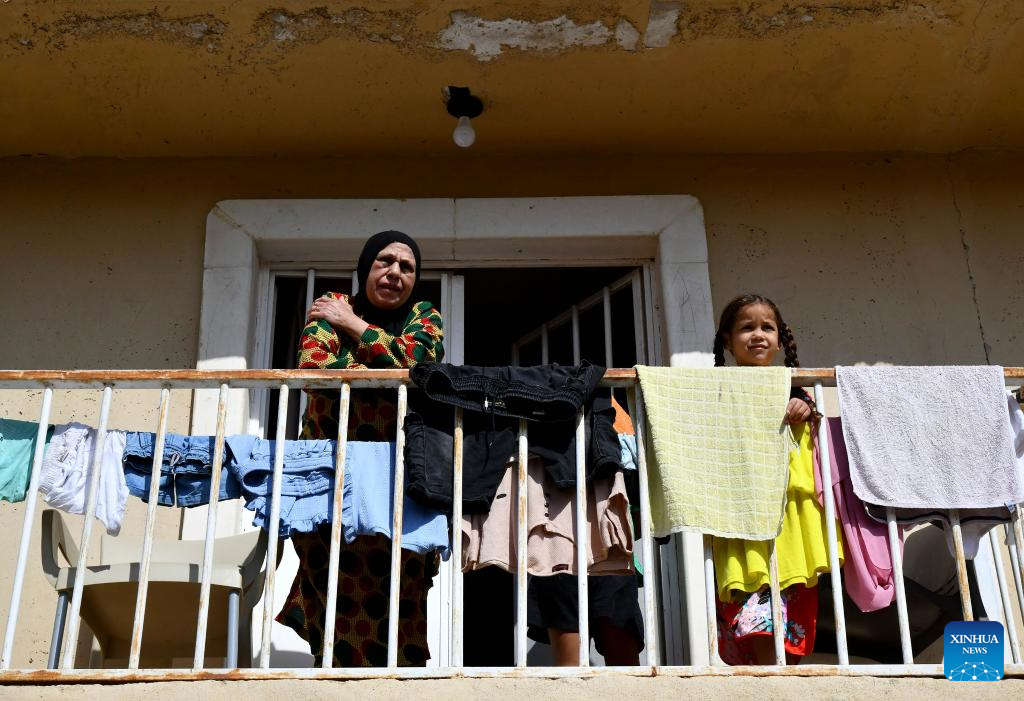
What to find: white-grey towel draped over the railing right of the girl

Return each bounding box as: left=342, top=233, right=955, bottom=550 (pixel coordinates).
left=836, top=366, right=1024, bottom=509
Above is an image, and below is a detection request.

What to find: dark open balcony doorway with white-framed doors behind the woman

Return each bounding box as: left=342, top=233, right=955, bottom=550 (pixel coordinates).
left=258, top=266, right=651, bottom=666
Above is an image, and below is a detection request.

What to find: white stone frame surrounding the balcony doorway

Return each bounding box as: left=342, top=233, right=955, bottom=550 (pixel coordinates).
left=195, top=194, right=715, bottom=664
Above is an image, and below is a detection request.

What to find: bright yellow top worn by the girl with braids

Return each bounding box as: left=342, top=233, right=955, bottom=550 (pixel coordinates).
left=714, top=424, right=843, bottom=601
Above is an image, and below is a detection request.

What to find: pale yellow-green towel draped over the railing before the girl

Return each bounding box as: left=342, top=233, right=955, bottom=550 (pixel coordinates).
left=637, top=365, right=790, bottom=540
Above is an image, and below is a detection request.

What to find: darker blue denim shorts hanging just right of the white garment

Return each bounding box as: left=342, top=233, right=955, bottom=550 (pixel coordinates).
left=124, top=431, right=242, bottom=507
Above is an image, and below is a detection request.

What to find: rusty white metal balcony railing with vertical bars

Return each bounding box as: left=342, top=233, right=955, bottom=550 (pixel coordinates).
left=0, top=368, right=1024, bottom=683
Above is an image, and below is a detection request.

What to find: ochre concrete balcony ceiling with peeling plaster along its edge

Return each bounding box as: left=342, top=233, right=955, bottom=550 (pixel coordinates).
left=0, top=0, right=1024, bottom=157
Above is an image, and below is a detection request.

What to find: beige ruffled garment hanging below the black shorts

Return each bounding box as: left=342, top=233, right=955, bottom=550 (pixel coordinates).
left=462, top=455, right=633, bottom=576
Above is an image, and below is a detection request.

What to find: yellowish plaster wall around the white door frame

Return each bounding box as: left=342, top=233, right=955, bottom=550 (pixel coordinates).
left=0, top=152, right=1024, bottom=666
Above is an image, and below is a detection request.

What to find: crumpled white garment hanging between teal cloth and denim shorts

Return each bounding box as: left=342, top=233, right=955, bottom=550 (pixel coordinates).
left=39, top=423, right=128, bottom=535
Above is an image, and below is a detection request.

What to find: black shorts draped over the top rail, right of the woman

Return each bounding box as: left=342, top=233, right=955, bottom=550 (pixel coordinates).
left=406, top=361, right=622, bottom=514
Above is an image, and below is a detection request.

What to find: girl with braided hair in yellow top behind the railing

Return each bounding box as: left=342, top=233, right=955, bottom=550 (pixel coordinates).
left=713, top=295, right=843, bottom=664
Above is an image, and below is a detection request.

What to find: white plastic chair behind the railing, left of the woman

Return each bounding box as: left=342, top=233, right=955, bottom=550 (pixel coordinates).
left=42, top=509, right=267, bottom=669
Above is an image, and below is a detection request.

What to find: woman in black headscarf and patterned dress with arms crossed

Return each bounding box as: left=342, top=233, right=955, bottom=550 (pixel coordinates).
left=278, top=231, right=444, bottom=667
